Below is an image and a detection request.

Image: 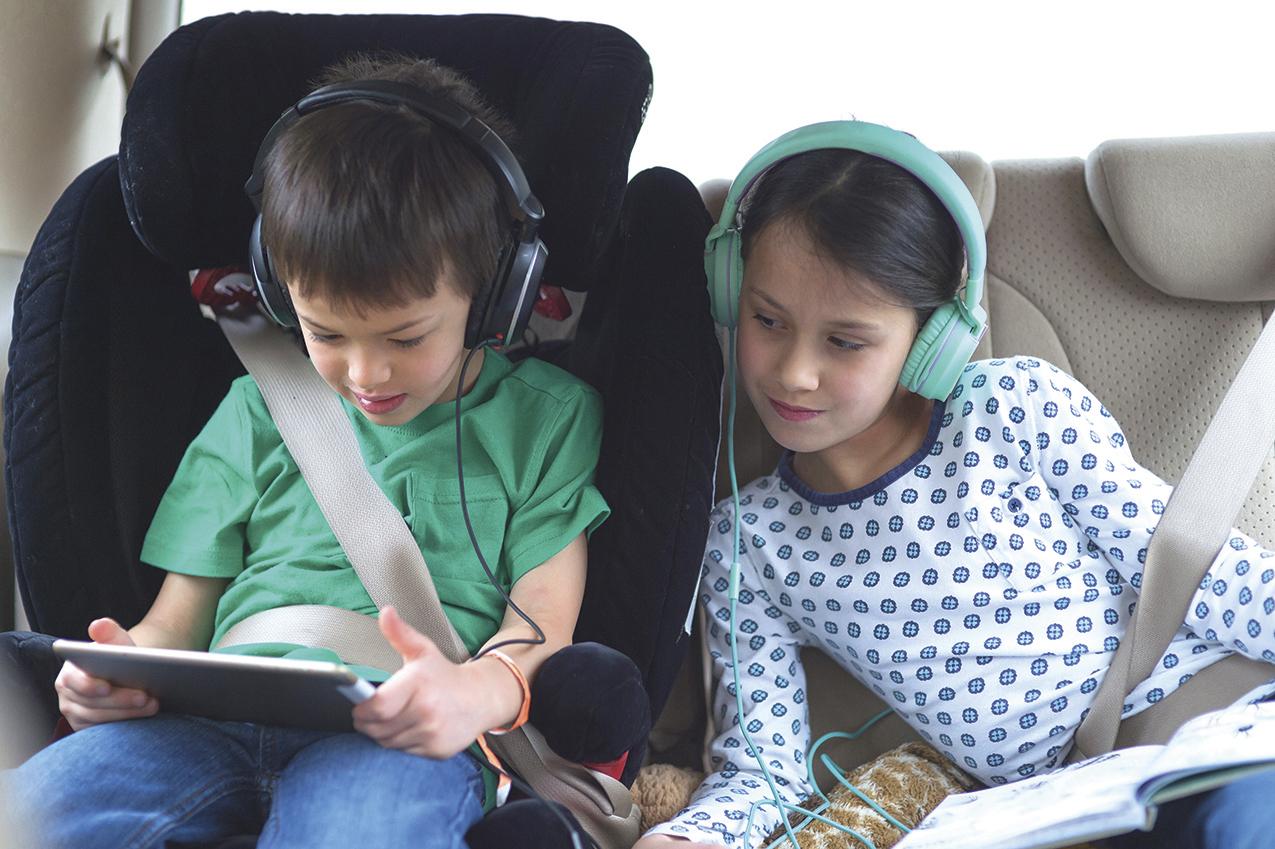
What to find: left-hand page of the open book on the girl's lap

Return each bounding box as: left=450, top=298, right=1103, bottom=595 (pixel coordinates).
left=895, top=746, right=1162, bottom=849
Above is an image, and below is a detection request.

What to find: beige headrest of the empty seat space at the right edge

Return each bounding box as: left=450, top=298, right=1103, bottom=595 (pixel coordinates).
left=1085, top=133, right=1275, bottom=301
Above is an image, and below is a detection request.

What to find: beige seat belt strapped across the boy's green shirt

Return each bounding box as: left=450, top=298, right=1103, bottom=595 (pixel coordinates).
left=206, top=299, right=641, bottom=849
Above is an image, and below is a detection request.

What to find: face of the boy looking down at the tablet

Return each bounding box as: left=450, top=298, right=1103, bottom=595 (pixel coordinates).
left=288, top=274, right=482, bottom=425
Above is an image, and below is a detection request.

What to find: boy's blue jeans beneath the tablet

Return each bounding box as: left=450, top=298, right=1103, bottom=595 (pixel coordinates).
left=0, top=714, right=483, bottom=849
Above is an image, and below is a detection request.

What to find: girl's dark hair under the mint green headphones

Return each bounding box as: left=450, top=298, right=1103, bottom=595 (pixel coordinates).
left=741, top=149, right=964, bottom=326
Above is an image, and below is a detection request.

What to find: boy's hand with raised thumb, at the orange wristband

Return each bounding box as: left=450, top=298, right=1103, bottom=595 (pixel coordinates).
left=353, top=607, right=518, bottom=758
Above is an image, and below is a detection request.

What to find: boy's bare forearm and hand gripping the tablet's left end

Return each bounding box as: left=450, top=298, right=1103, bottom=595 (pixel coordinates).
left=54, top=572, right=227, bottom=730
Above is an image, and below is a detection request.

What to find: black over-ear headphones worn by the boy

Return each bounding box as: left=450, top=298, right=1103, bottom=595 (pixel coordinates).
left=244, top=79, right=548, bottom=349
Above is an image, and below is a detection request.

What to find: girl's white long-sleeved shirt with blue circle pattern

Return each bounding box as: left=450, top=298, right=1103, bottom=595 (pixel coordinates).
left=655, top=357, right=1275, bottom=845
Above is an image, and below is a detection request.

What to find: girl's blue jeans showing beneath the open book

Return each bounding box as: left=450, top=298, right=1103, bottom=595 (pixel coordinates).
left=1108, top=771, right=1275, bottom=849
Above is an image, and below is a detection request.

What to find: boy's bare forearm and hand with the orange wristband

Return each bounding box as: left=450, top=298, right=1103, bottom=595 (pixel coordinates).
left=353, top=534, right=587, bottom=758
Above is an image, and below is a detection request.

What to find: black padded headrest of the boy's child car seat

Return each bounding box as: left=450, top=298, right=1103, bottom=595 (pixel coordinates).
left=120, top=13, right=650, bottom=289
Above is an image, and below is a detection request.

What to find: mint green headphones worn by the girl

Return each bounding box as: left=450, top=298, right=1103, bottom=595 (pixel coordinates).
left=704, top=121, right=987, bottom=400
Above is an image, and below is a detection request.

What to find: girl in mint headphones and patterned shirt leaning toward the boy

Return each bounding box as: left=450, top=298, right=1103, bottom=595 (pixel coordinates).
left=639, top=122, right=1275, bottom=849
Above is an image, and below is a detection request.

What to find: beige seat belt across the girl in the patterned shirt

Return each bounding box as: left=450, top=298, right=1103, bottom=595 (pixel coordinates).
left=1067, top=307, right=1275, bottom=761
